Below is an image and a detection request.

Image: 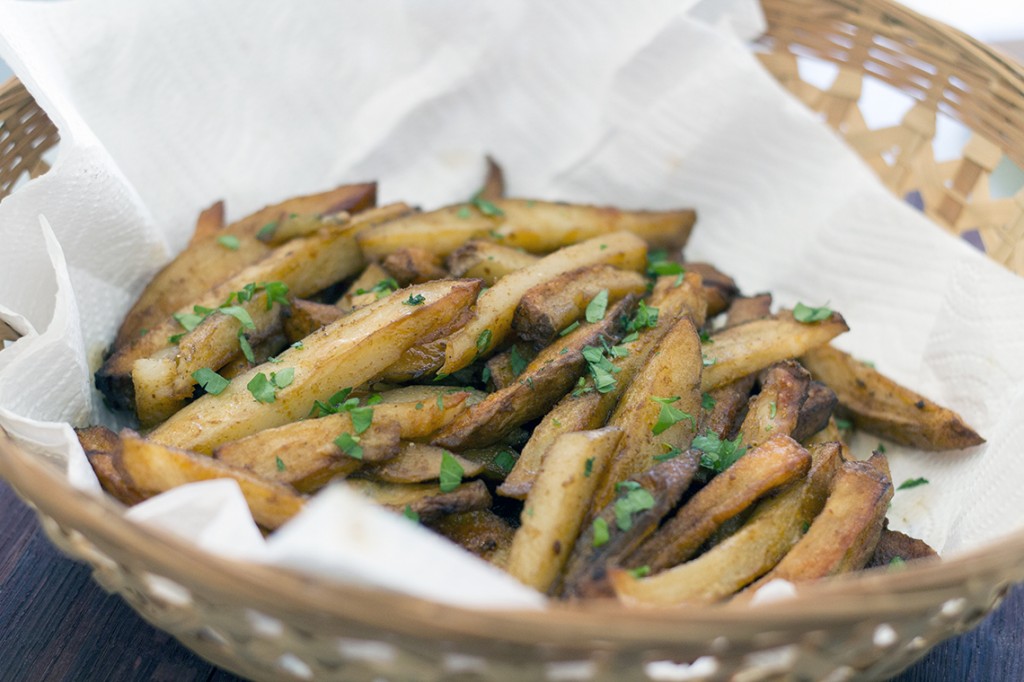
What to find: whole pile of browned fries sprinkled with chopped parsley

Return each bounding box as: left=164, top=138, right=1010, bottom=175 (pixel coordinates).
left=78, top=163, right=982, bottom=605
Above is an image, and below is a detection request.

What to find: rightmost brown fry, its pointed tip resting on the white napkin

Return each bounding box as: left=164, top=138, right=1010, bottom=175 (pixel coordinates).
left=801, top=345, right=985, bottom=451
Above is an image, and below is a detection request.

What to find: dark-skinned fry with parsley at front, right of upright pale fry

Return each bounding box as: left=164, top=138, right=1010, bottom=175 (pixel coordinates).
left=559, top=451, right=700, bottom=599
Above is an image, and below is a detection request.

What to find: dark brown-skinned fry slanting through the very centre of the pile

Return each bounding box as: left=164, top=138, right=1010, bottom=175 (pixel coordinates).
left=433, top=296, right=636, bottom=451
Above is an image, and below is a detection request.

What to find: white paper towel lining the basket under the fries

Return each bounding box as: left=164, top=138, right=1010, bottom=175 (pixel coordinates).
left=0, top=0, right=1024, bottom=607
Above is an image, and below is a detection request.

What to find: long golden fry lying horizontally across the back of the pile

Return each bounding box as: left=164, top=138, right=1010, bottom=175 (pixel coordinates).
left=359, top=199, right=696, bottom=259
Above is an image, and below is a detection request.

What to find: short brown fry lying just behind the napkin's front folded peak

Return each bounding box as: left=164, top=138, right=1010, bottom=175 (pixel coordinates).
left=344, top=478, right=490, bottom=523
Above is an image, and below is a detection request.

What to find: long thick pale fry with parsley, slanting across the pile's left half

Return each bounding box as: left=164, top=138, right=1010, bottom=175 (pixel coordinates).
left=150, top=280, right=479, bottom=453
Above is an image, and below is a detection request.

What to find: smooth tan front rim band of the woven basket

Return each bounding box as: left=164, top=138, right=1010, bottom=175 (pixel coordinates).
left=0, top=430, right=1024, bottom=649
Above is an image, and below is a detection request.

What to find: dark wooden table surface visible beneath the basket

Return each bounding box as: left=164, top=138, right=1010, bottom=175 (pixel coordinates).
left=0, top=482, right=1024, bottom=682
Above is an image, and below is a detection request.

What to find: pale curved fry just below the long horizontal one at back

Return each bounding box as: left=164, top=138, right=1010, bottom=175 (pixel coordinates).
left=441, top=231, right=647, bottom=374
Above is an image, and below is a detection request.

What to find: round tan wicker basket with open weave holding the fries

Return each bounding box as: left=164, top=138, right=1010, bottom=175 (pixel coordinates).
left=0, top=0, right=1024, bottom=681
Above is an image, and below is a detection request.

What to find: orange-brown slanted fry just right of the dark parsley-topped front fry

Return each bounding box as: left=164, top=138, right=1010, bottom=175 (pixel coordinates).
left=627, top=433, right=811, bottom=572
